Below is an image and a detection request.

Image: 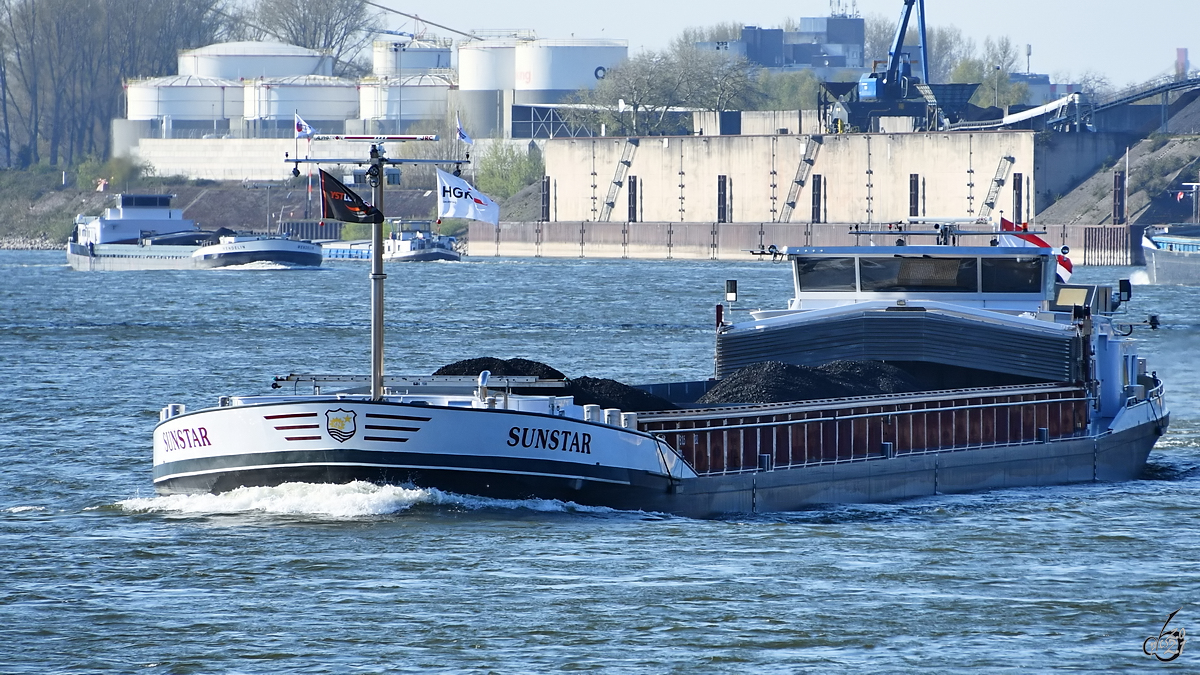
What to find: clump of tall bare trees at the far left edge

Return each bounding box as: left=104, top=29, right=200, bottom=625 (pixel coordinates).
left=0, top=0, right=230, bottom=166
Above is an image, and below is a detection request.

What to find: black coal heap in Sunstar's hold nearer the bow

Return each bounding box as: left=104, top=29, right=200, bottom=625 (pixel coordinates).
left=433, top=357, right=679, bottom=412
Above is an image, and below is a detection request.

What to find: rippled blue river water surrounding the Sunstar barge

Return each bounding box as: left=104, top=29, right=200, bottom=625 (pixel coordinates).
left=0, top=251, right=1200, bottom=674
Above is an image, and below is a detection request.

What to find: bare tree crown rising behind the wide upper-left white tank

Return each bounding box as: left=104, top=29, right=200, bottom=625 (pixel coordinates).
left=253, top=0, right=383, bottom=74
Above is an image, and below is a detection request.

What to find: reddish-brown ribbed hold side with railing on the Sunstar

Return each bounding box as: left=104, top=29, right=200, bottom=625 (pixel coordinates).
left=640, top=388, right=1091, bottom=476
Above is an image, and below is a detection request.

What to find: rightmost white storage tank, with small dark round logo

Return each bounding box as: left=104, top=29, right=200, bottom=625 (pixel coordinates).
left=513, top=40, right=629, bottom=104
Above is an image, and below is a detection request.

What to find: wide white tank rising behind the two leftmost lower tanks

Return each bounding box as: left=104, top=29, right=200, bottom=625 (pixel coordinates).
left=179, top=42, right=334, bottom=80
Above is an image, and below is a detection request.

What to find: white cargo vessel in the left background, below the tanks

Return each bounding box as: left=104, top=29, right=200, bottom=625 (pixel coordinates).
left=66, top=193, right=323, bottom=271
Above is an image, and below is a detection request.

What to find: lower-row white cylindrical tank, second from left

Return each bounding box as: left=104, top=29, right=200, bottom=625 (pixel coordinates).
left=244, top=74, right=359, bottom=123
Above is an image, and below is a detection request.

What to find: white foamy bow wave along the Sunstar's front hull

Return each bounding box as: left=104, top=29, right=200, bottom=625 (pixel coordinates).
left=118, top=482, right=612, bottom=519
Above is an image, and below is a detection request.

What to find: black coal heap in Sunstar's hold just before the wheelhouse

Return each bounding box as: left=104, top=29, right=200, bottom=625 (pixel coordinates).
left=696, top=360, right=926, bottom=405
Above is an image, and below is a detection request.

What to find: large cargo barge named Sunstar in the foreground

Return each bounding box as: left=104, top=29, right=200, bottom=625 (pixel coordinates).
left=154, top=206, right=1169, bottom=516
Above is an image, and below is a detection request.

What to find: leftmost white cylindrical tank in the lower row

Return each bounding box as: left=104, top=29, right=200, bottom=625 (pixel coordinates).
left=125, top=76, right=244, bottom=120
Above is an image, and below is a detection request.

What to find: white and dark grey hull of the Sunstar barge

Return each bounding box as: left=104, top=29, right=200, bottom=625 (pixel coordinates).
left=155, top=389, right=1168, bottom=518
